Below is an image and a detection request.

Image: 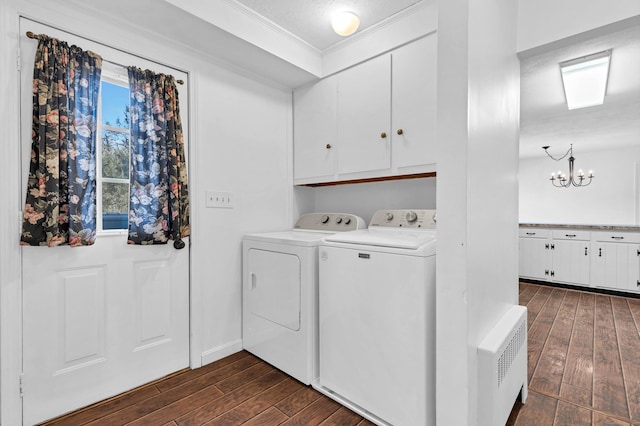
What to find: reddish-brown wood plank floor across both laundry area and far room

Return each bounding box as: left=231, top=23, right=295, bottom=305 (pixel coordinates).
left=46, top=283, right=640, bottom=426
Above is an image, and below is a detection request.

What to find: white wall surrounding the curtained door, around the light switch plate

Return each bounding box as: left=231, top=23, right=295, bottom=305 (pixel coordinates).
left=0, top=0, right=292, bottom=425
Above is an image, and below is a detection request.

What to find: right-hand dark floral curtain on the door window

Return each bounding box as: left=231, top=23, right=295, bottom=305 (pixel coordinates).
left=128, top=67, right=190, bottom=249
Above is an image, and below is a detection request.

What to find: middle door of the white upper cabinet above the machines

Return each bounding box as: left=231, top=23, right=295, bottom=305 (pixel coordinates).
left=338, top=55, right=391, bottom=174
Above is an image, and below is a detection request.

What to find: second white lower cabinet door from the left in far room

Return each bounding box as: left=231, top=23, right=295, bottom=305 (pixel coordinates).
left=551, top=240, right=590, bottom=285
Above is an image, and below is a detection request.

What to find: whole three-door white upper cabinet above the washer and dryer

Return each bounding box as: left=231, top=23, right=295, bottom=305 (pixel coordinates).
left=293, top=33, right=437, bottom=185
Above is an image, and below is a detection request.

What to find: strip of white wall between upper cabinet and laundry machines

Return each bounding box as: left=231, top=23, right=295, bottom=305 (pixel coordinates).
left=295, top=178, right=436, bottom=224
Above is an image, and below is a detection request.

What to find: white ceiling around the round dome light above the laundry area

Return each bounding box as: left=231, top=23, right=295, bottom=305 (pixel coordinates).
left=235, top=0, right=423, bottom=51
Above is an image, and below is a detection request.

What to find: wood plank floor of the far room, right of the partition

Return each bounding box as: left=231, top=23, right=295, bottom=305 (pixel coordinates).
left=508, top=283, right=640, bottom=426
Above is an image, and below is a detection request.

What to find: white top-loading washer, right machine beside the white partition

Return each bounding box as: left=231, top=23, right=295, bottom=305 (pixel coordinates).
left=314, top=210, right=436, bottom=426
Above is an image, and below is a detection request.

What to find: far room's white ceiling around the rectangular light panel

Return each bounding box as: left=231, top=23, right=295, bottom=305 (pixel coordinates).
left=520, top=19, right=640, bottom=157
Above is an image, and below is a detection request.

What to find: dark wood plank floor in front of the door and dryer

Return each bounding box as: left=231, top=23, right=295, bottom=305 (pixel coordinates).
left=44, top=351, right=373, bottom=426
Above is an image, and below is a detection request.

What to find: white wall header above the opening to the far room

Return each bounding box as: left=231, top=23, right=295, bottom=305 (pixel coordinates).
left=518, top=0, right=640, bottom=52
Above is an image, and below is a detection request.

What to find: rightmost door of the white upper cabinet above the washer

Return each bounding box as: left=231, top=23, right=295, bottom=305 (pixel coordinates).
left=391, top=34, right=438, bottom=168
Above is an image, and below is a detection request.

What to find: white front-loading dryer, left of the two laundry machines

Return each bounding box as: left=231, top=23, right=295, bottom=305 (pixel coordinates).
left=242, top=213, right=366, bottom=385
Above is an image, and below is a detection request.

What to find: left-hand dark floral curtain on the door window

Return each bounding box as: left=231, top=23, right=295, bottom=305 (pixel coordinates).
left=20, top=35, right=102, bottom=247
